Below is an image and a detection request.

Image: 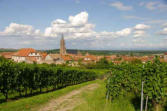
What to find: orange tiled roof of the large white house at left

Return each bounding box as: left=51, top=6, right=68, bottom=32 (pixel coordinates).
left=14, top=48, right=36, bottom=57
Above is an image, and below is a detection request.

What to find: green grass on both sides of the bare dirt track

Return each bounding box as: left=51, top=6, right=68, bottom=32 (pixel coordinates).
left=0, top=80, right=138, bottom=111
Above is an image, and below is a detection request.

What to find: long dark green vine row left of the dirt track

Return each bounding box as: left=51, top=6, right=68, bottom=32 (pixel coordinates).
left=0, top=57, right=97, bottom=100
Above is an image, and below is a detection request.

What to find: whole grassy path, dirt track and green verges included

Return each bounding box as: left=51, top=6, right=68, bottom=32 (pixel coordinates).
left=0, top=80, right=135, bottom=111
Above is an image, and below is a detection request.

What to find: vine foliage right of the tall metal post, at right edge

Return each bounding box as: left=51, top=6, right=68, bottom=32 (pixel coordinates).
left=143, top=58, right=167, bottom=104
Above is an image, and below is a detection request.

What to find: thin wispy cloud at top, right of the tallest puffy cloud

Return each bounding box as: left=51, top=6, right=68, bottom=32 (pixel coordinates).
left=110, top=1, right=133, bottom=11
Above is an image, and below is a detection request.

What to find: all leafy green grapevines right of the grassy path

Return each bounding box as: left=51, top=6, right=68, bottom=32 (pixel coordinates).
left=106, top=58, right=167, bottom=111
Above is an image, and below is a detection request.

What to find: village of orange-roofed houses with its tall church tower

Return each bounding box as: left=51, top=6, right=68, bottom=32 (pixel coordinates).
left=0, top=35, right=167, bottom=66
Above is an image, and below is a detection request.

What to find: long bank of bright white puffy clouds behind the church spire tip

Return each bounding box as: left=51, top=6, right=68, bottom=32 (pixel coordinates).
left=0, top=12, right=132, bottom=39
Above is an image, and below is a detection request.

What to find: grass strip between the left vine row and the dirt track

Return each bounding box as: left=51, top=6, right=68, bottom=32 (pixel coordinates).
left=0, top=80, right=97, bottom=111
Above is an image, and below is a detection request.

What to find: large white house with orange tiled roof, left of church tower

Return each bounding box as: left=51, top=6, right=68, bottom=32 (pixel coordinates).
left=12, top=48, right=46, bottom=63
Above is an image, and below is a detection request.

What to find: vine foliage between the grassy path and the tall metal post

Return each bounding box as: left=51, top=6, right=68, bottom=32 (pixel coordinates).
left=106, top=63, right=142, bottom=99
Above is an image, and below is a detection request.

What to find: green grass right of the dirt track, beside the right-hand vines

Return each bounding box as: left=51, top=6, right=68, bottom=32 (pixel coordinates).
left=74, top=81, right=135, bottom=111
